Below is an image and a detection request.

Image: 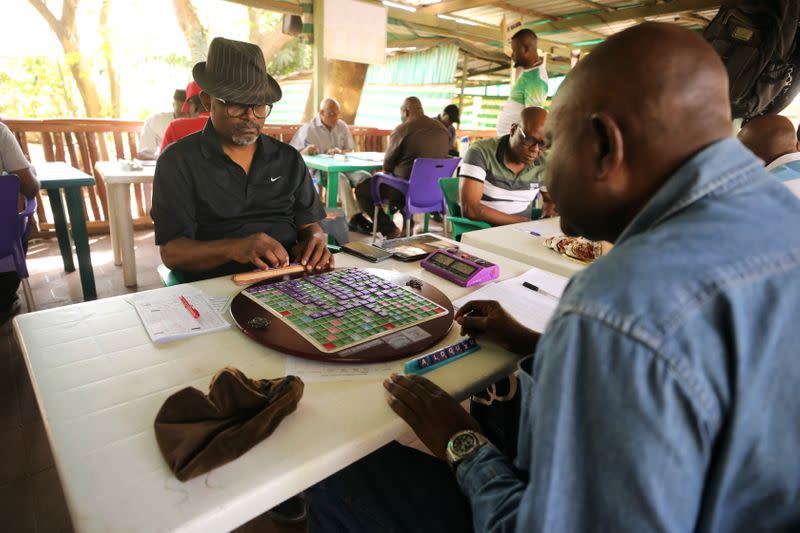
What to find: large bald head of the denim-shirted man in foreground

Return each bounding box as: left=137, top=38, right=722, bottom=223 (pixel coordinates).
left=546, top=22, right=731, bottom=240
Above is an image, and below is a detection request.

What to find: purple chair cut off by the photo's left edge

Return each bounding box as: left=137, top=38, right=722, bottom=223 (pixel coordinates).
left=0, top=174, right=36, bottom=311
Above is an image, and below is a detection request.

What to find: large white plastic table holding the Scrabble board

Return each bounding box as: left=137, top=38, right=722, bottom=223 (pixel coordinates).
left=14, top=246, right=528, bottom=533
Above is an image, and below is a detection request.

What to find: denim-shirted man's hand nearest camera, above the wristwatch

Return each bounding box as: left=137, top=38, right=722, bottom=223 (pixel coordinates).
left=383, top=374, right=481, bottom=460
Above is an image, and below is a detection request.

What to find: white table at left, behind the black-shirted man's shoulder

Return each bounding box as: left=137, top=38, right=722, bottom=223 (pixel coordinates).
left=94, top=161, right=156, bottom=287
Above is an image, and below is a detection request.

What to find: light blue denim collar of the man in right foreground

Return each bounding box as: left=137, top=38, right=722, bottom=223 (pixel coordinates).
left=615, top=138, right=768, bottom=244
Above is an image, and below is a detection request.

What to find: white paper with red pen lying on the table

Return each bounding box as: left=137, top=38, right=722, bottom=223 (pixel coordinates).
left=128, top=285, right=230, bottom=343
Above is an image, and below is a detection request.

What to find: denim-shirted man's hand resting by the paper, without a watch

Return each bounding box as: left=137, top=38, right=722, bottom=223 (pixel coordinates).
left=455, top=300, right=540, bottom=354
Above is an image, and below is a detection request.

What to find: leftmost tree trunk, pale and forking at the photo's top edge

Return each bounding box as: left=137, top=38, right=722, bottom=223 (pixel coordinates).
left=28, top=0, right=100, bottom=117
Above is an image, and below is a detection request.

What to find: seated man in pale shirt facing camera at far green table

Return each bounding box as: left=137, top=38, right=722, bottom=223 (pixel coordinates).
left=289, top=98, right=372, bottom=233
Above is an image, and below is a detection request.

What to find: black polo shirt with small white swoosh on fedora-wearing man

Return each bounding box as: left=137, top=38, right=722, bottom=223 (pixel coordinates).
left=150, top=120, right=325, bottom=277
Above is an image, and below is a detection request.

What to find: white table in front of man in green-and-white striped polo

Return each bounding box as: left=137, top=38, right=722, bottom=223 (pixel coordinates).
left=461, top=217, right=586, bottom=277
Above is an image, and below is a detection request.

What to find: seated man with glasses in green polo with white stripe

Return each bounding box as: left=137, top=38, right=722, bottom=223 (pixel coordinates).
left=459, top=107, right=554, bottom=226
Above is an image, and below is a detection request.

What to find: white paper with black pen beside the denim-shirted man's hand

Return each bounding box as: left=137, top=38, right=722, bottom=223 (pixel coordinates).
left=453, top=268, right=569, bottom=332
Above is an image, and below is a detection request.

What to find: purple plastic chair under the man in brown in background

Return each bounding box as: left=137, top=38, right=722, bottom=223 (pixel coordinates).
left=371, top=157, right=461, bottom=241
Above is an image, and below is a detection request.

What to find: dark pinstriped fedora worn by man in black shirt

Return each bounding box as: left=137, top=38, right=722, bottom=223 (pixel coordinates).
left=192, top=37, right=281, bottom=105
